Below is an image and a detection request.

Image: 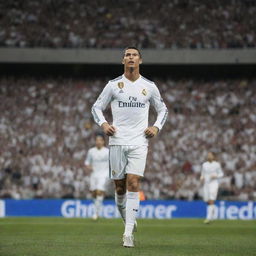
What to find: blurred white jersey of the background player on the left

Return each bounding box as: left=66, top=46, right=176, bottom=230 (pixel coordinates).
left=85, top=147, right=109, bottom=177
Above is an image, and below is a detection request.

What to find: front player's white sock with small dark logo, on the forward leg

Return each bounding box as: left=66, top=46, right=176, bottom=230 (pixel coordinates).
left=124, top=191, right=140, bottom=236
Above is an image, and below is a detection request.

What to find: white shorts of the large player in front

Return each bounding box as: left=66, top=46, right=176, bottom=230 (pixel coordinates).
left=109, top=145, right=148, bottom=180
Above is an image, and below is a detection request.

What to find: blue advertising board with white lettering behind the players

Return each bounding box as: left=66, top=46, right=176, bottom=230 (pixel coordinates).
left=0, top=199, right=256, bottom=220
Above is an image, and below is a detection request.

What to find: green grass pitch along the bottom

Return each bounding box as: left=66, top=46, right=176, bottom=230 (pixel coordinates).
left=0, top=218, right=256, bottom=256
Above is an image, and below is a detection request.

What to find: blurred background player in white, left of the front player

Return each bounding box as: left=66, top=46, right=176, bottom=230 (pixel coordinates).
left=85, top=134, right=109, bottom=220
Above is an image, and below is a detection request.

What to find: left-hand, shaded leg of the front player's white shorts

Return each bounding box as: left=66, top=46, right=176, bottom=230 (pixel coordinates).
left=109, top=145, right=127, bottom=180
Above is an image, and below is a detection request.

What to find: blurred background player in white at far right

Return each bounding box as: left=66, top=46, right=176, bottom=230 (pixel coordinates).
left=200, top=152, right=223, bottom=224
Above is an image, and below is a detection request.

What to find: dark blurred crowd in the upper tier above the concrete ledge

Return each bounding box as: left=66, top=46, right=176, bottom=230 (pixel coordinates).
left=0, top=0, right=256, bottom=49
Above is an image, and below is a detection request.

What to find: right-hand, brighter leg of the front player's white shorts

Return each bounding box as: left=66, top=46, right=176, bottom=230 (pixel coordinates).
left=125, top=146, right=148, bottom=177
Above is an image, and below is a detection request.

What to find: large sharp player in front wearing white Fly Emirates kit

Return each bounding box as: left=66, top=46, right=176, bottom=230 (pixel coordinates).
left=92, top=47, right=168, bottom=247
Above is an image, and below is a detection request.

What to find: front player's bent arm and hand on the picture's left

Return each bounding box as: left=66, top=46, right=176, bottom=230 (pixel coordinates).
left=92, top=83, right=115, bottom=136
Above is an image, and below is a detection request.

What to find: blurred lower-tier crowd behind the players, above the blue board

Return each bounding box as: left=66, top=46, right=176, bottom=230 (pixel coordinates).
left=0, top=77, right=256, bottom=200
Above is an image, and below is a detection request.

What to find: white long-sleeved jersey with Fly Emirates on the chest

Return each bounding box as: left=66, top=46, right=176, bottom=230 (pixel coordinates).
left=92, top=75, right=168, bottom=145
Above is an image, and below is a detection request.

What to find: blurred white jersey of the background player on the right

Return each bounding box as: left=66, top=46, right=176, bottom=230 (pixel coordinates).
left=201, top=161, right=223, bottom=183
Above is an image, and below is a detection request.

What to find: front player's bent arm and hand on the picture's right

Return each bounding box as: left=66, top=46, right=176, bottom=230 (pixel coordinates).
left=145, top=84, right=168, bottom=138
